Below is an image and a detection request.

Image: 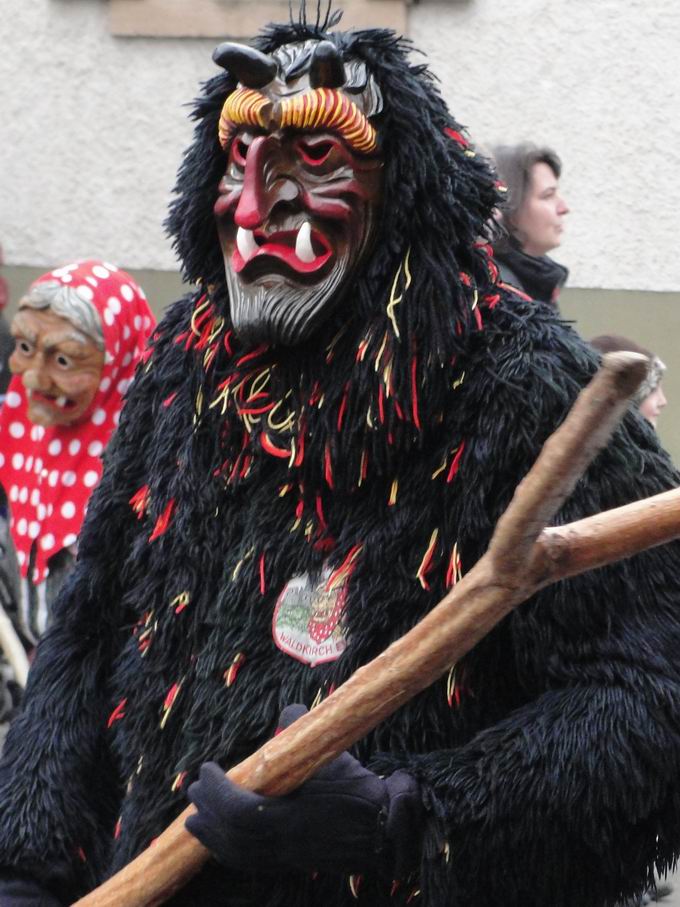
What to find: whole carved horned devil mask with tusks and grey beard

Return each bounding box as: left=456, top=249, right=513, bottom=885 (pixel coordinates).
left=213, top=41, right=382, bottom=346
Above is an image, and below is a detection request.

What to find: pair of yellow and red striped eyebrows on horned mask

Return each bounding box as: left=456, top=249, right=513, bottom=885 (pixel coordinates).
left=219, top=88, right=378, bottom=154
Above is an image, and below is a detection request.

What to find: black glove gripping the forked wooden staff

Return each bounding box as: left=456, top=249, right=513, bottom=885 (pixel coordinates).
left=186, top=706, right=424, bottom=879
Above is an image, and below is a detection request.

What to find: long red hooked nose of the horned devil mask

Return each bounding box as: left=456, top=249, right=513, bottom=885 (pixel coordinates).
left=234, top=135, right=300, bottom=230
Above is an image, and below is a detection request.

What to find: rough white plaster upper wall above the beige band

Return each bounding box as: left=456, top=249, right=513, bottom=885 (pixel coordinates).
left=0, top=0, right=680, bottom=292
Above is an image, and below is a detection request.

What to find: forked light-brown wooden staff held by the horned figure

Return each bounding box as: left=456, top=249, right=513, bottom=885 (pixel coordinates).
left=77, top=353, right=680, bottom=907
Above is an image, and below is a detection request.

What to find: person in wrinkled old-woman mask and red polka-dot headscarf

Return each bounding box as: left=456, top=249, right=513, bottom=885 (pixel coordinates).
left=0, top=260, right=155, bottom=712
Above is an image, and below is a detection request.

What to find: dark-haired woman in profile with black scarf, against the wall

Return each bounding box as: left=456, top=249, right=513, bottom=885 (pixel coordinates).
left=492, top=142, right=569, bottom=303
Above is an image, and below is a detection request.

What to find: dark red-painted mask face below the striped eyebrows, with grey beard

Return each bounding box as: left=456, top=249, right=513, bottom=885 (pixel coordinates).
left=215, top=59, right=382, bottom=345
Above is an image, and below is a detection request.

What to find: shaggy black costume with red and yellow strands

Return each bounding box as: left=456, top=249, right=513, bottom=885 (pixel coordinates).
left=0, top=12, right=680, bottom=907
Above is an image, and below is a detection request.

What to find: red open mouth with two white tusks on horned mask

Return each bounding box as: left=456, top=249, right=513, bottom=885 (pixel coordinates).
left=231, top=221, right=333, bottom=274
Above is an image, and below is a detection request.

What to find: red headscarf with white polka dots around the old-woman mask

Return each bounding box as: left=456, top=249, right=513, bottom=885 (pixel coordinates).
left=0, top=260, right=155, bottom=584
